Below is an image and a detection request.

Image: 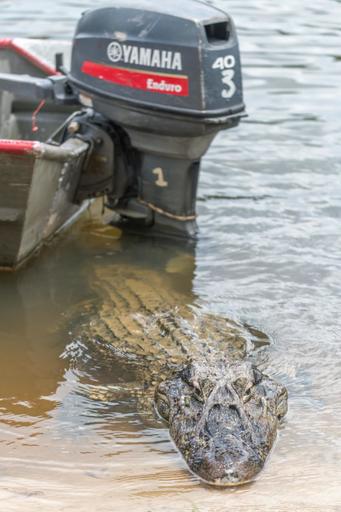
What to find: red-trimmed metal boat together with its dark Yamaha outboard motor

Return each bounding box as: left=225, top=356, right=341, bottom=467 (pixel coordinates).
left=0, top=0, right=246, bottom=269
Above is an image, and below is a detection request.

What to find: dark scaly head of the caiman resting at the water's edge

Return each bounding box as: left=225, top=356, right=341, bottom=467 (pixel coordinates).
left=155, top=361, right=287, bottom=486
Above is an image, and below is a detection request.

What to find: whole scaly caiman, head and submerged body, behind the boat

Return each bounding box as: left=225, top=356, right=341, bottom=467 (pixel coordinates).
left=71, top=234, right=287, bottom=486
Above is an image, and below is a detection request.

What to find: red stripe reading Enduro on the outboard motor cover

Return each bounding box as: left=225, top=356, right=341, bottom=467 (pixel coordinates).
left=82, top=61, right=189, bottom=96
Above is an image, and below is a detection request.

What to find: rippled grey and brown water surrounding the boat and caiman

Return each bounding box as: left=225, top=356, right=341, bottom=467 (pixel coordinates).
left=0, top=0, right=341, bottom=512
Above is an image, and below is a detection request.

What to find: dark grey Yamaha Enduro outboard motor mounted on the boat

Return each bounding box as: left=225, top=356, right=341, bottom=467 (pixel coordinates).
left=0, top=0, right=245, bottom=237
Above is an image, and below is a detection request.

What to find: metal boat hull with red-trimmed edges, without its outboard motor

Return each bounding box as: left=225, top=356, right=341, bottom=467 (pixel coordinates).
left=0, top=39, right=88, bottom=270
